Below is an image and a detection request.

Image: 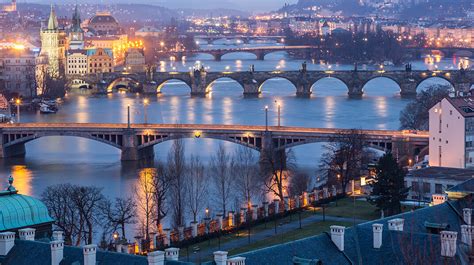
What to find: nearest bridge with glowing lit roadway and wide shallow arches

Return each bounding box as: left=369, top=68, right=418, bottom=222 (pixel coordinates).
left=0, top=123, right=429, bottom=161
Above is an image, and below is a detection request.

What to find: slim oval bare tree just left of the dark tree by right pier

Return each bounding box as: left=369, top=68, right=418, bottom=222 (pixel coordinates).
left=232, top=147, right=263, bottom=207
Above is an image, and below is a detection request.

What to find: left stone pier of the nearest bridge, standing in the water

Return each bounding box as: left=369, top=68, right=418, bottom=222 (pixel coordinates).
left=121, top=129, right=155, bottom=161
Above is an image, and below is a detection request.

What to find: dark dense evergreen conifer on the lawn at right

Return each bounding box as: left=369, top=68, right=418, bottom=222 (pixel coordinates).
left=372, top=153, right=408, bottom=215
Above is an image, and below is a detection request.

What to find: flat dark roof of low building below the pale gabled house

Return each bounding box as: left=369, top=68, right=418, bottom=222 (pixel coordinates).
left=407, top=167, right=474, bottom=181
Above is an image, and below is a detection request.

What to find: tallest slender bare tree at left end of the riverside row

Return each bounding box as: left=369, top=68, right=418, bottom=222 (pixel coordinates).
left=165, top=139, right=186, bottom=227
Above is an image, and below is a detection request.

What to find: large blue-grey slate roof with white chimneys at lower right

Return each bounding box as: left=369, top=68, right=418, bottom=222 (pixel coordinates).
left=238, top=201, right=468, bottom=265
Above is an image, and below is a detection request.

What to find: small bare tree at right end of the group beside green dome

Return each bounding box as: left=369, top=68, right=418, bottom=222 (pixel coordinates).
left=101, top=197, right=137, bottom=238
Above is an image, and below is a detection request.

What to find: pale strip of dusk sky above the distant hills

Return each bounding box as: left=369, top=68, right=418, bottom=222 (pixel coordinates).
left=24, top=0, right=298, bottom=13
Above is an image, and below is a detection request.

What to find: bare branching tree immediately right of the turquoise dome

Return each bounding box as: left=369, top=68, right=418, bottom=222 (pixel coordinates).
left=41, top=184, right=81, bottom=245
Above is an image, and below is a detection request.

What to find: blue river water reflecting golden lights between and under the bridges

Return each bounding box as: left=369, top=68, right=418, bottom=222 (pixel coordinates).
left=0, top=39, right=466, bottom=229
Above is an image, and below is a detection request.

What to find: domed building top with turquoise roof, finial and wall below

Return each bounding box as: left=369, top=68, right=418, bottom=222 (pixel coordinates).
left=0, top=177, right=53, bottom=236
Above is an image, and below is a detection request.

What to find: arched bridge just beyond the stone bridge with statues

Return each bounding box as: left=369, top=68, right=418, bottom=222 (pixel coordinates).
left=166, top=46, right=319, bottom=61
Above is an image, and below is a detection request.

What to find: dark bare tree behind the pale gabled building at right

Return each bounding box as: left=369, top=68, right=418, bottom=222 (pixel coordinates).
left=400, top=85, right=451, bottom=130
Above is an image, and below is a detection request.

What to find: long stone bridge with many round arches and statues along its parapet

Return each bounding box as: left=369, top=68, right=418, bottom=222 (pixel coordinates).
left=68, top=65, right=474, bottom=97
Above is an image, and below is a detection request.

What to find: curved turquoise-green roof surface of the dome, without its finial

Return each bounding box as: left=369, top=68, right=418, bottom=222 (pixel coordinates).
left=0, top=191, right=54, bottom=231
